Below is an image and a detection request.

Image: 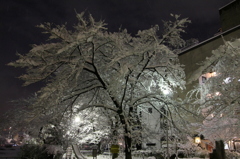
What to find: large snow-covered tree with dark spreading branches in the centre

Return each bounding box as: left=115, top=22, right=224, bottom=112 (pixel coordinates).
left=9, top=13, right=189, bottom=159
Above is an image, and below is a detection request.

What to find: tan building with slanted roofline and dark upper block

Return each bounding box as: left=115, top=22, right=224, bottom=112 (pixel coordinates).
left=179, top=0, right=240, bottom=152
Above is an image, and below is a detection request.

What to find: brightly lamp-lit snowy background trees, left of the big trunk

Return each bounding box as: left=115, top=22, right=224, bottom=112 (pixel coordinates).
left=0, top=96, right=111, bottom=149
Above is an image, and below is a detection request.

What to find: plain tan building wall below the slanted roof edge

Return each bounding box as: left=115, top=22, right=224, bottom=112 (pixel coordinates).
left=179, top=25, right=240, bottom=98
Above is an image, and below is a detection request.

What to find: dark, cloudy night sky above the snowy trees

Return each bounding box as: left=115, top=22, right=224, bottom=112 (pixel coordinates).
left=0, top=0, right=232, bottom=114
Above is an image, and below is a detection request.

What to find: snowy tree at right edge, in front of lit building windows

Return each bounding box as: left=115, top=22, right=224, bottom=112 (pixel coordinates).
left=188, top=39, right=240, bottom=141
